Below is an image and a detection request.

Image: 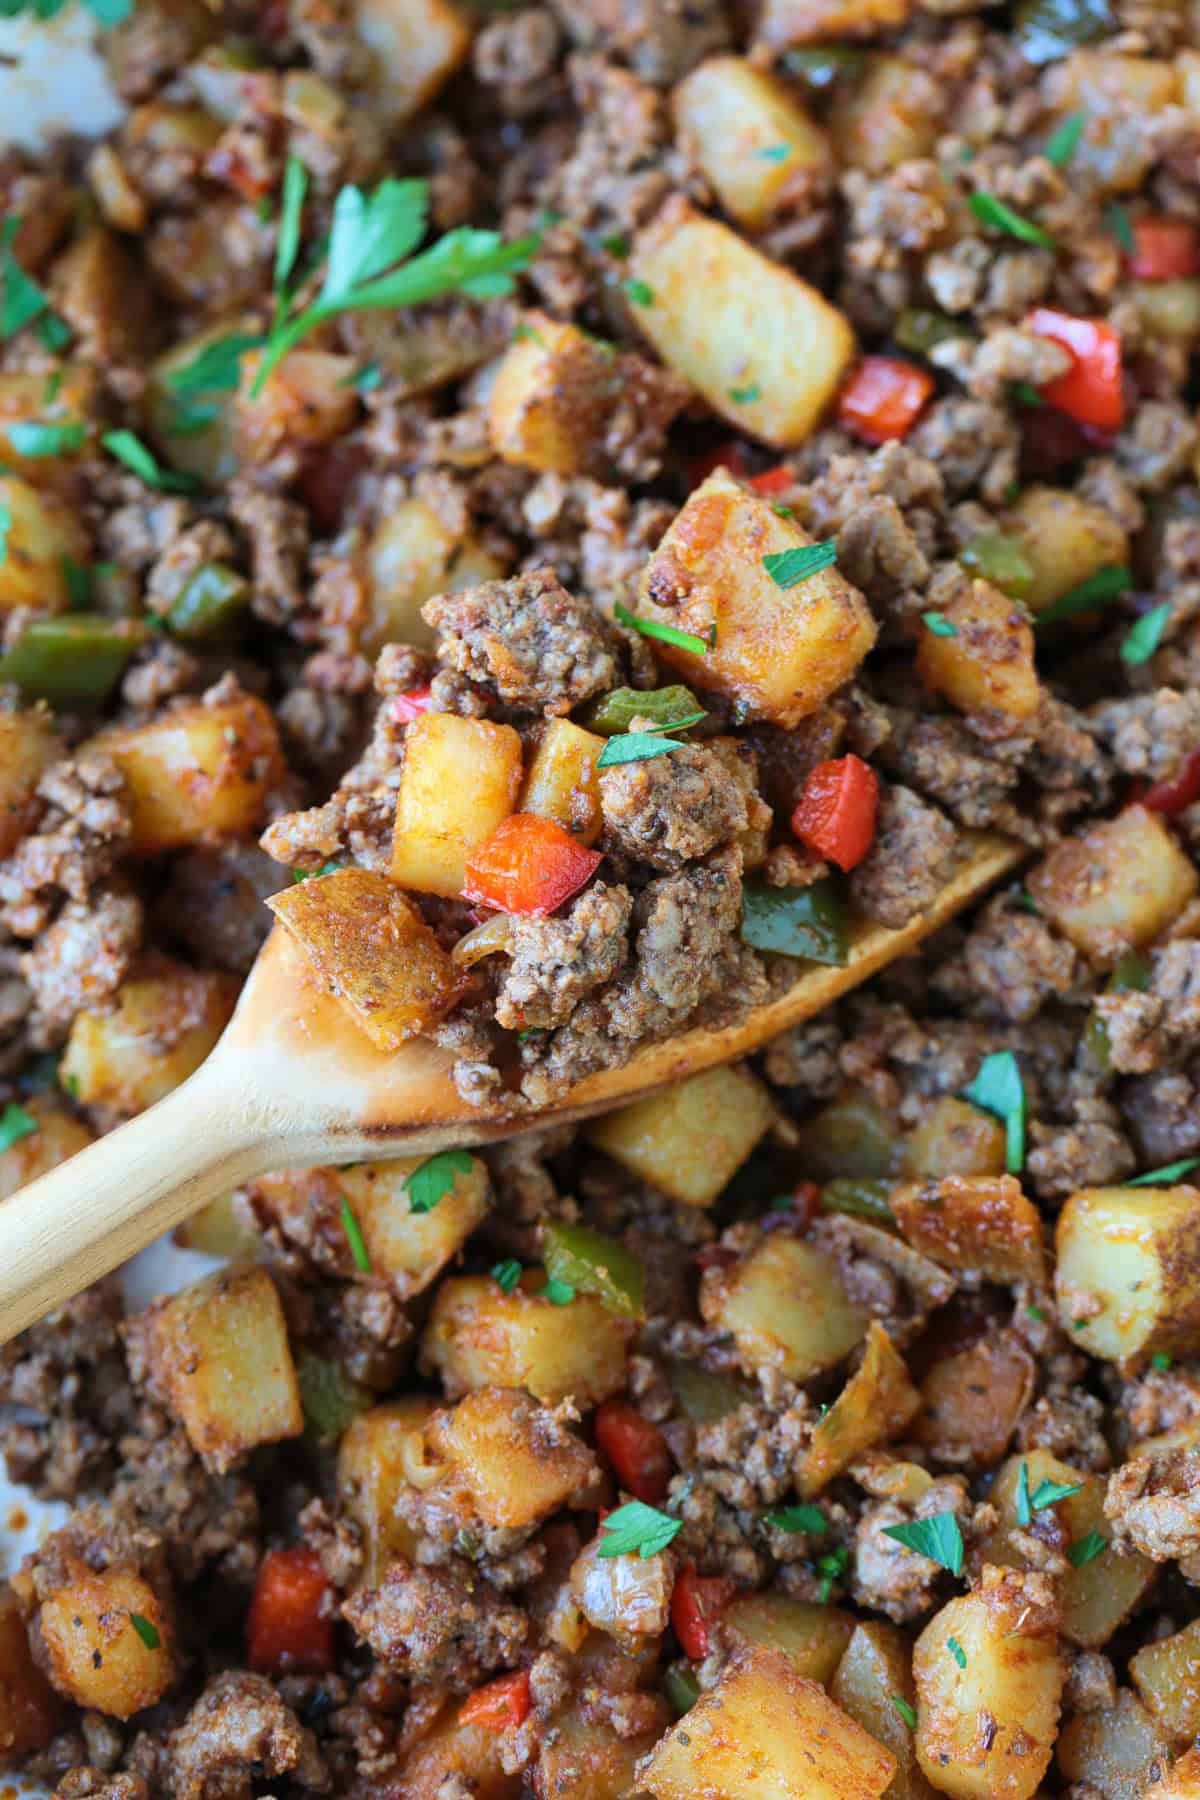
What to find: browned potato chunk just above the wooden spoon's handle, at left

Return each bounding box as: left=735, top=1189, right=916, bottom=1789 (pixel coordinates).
left=59, top=956, right=237, bottom=1114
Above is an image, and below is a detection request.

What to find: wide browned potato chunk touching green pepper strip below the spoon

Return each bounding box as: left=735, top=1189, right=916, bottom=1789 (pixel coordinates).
left=421, top=1274, right=633, bottom=1406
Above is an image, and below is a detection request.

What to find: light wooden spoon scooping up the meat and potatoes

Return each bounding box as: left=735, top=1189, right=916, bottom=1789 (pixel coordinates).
left=0, top=833, right=1025, bottom=1343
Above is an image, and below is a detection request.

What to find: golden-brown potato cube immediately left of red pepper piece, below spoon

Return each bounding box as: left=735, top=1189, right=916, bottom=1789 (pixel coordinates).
left=425, top=1388, right=597, bottom=1526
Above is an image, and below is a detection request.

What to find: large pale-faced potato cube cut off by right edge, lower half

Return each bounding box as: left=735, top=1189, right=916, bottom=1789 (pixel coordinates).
left=1054, top=1188, right=1200, bottom=1363
